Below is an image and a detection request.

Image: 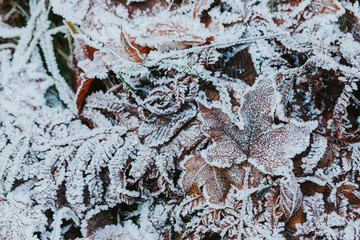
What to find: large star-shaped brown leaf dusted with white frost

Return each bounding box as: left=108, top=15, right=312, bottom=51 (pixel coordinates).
left=199, top=79, right=315, bottom=175
